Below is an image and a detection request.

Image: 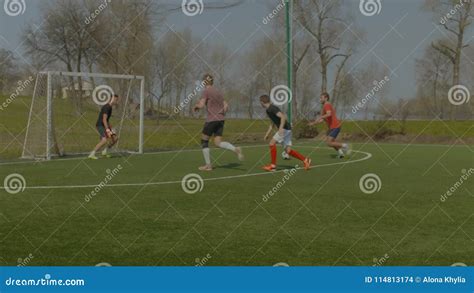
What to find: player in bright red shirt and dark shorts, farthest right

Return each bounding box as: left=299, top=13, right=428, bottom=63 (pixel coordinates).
left=309, top=93, right=351, bottom=159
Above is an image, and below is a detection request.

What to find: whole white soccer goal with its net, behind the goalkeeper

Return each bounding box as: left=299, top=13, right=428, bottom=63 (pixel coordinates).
left=22, top=71, right=145, bottom=160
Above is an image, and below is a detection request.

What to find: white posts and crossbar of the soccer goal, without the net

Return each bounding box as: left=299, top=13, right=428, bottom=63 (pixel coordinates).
left=21, top=71, right=145, bottom=160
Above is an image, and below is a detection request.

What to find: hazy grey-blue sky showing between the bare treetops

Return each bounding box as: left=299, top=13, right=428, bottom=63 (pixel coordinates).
left=0, top=0, right=462, bottom=99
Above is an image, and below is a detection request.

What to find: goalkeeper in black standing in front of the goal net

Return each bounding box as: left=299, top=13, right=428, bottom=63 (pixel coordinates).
left=89, top=95, right=119, bottom=160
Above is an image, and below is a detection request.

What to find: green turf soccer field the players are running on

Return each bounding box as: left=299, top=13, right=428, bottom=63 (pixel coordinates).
left=0, top=141, right=474, bottom=266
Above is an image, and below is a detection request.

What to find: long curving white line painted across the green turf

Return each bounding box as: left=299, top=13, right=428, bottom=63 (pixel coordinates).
left=0, top=146, right=372, bottom=189
